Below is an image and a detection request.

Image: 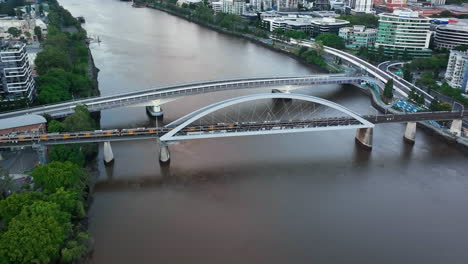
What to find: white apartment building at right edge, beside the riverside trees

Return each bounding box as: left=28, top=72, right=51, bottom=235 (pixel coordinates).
left=445, top=50, right=468, bottom=93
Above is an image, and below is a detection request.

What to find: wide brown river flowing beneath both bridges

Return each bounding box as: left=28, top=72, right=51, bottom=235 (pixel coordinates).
left=55, top=0, right=468, bottom=264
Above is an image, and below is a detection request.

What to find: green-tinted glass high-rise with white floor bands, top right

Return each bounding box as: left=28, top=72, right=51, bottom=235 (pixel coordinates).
left=375, top=9, right=432, bottom=58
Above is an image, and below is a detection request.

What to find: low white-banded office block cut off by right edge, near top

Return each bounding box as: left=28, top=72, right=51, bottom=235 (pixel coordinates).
left=434, top=21, right=468, bottom=49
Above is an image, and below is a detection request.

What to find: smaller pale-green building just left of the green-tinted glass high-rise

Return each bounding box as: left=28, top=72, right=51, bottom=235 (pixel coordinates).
left=338, top=26, right=377, bottom=49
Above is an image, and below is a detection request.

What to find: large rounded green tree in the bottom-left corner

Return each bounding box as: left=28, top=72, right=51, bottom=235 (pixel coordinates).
left=0, top=201, right=71, bottom=264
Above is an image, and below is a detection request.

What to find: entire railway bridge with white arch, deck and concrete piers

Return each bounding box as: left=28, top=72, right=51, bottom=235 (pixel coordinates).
left=0, top=93, right=468, bottom=163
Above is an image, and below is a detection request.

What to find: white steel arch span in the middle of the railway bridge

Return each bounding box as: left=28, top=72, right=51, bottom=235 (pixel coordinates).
left=160, top=93, right=374, bottom=142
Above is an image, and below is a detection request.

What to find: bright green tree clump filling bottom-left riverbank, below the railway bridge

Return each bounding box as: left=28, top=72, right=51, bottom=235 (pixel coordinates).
left=0, top=172, right=89, bottom=264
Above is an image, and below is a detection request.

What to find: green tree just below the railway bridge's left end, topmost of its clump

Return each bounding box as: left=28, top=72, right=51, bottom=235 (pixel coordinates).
left=31, top=161, right=87, bottom=193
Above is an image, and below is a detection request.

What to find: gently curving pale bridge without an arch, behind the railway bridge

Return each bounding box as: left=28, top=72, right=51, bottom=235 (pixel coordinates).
left=0, top=74, right=372, bottom=118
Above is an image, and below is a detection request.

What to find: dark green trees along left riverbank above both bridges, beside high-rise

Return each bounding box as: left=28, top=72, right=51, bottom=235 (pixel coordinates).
left=35, top=0, right=92, bottom=104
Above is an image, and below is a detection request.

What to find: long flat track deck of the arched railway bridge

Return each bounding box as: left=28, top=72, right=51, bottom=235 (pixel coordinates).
left=0, top=112, right=468, bottom=148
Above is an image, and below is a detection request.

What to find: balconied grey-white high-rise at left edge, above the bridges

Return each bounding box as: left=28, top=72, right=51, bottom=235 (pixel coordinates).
left=0, top=42, right=36, bottom=102
